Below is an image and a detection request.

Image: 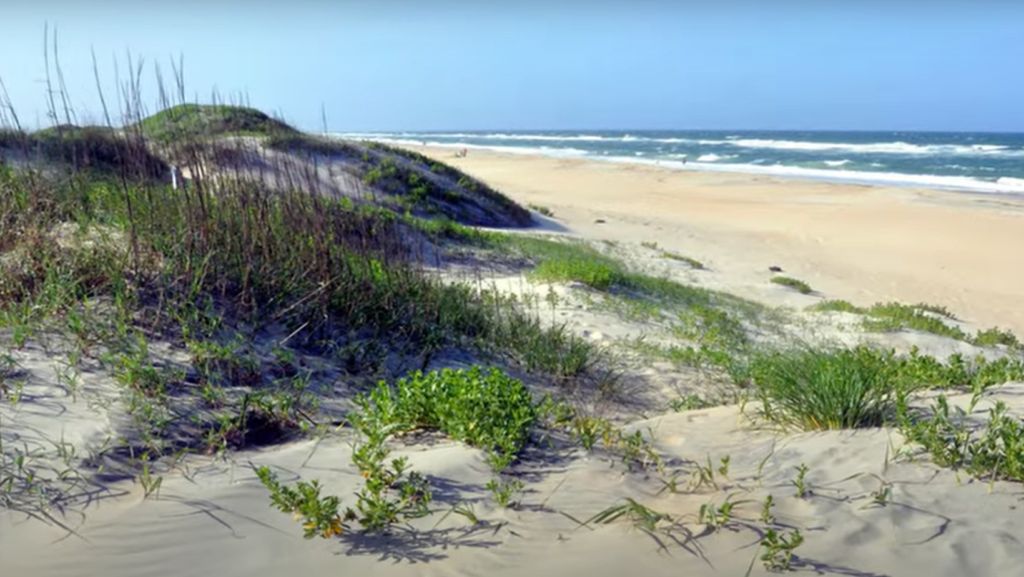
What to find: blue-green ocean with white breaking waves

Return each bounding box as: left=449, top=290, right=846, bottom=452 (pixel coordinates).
left=337, top=130, right=1024, bottom=195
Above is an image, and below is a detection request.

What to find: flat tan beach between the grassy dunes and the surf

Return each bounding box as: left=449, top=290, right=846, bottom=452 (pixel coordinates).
left=400, top=145, right=1024, bottom=334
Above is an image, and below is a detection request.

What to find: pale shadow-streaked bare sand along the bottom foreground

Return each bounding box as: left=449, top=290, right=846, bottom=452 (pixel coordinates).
left=0, top=385, right=1024, bottom=577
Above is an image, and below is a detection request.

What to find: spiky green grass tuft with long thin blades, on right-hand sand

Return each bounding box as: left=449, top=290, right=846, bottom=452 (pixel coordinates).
left=746, top=347, right=896, bottom=430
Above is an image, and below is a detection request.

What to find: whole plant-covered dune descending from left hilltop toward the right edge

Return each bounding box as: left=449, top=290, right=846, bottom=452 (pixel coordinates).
left=0, top=68, right=1024, bottom=569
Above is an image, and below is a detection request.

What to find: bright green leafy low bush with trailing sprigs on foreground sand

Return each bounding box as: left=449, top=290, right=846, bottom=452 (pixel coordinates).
left=257, top=367, right=538, bottom=537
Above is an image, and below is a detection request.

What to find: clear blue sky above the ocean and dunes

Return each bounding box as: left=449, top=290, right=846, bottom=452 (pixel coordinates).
left=0, top=0, right=1024, bottom=131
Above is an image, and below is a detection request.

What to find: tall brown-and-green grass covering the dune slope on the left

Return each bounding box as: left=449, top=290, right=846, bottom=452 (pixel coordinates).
left=0, top=60, right=611, bottom=520
